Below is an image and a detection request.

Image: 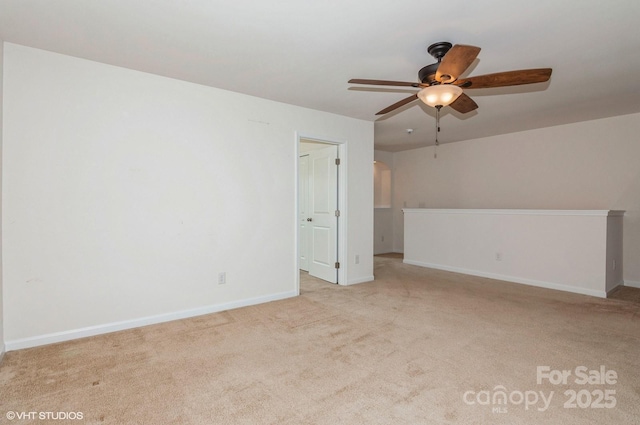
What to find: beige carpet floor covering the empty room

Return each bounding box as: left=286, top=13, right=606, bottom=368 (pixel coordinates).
left=0, top=256, right=640, bottom=425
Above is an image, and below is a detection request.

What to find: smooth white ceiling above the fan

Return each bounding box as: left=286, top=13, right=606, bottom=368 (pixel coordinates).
left=0, top=0, right=640, bottom=151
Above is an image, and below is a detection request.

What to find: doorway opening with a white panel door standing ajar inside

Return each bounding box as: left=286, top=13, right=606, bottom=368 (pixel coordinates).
left=296, top=136, right=346, bottom=290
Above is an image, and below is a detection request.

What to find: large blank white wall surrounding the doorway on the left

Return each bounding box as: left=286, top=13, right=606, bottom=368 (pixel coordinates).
left=3, top=43, right=373, bottom=349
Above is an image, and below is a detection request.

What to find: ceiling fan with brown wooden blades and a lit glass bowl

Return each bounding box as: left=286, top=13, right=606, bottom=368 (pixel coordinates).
left=349, top=42, right=551, bottom=115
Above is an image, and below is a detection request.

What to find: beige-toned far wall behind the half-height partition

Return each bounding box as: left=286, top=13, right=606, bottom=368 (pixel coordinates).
left=394, top=114, right=640, bottom=284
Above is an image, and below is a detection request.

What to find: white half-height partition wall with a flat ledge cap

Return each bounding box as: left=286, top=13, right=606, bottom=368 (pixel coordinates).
left=403, top=208, right=624, bottom=297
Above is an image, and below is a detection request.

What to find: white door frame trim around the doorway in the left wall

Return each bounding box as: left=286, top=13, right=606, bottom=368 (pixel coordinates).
left=294, top=131, right=348, bottom=295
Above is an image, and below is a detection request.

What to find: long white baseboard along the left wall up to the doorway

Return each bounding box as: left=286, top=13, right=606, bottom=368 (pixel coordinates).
left=6, top=291, right=298, bottom=351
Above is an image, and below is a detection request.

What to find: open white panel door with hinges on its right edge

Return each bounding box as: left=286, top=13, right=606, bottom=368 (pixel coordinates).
left=308, top=145, right=338, bottom=283
